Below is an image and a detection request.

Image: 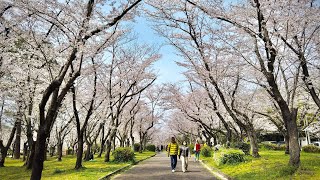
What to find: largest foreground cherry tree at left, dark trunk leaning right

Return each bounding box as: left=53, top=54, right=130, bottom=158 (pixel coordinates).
left=0, top=0, right=140, bottom=179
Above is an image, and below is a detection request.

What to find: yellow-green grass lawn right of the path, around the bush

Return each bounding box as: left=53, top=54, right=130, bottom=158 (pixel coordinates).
left=202, top=150, right=320, bottom=180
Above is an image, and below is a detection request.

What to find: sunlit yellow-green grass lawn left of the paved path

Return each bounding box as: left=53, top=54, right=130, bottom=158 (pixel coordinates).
left=0, top=152, right=155, bottom=180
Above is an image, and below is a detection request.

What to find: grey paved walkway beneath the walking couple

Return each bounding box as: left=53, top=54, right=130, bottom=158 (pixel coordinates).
left=112, top=152, right=216, bottom=180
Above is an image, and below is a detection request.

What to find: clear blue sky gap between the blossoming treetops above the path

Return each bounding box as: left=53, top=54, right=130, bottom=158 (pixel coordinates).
left=133, top=17, right=184, bottom=84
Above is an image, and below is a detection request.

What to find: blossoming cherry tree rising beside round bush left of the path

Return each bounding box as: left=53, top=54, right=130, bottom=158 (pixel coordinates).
left=101, top=41, right=159, bottom=162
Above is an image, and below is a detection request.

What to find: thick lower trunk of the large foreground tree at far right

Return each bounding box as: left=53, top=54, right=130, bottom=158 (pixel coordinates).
left=287, top=108, right=300, bottom=167
